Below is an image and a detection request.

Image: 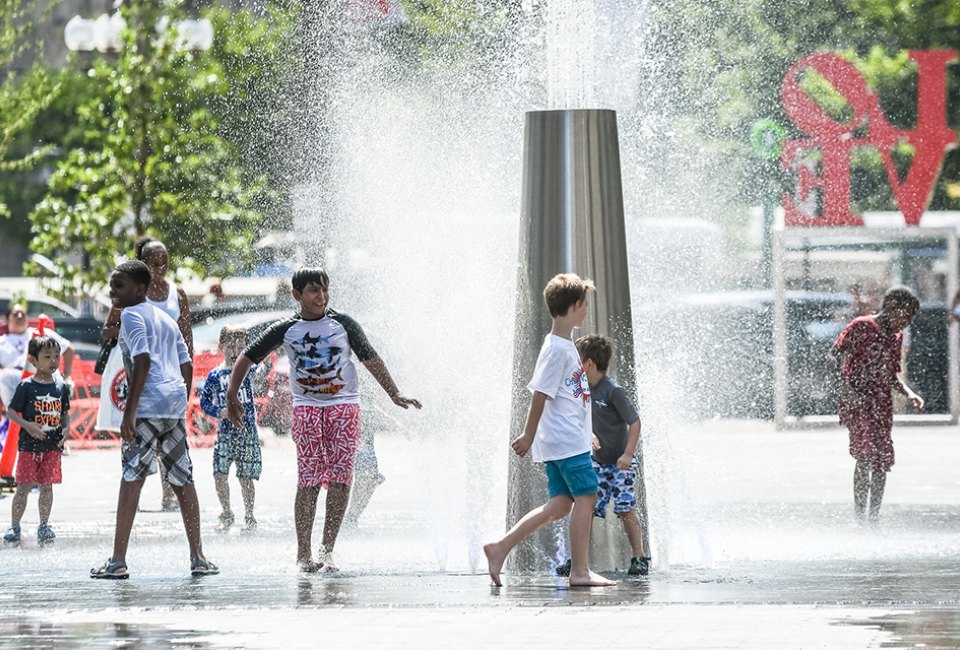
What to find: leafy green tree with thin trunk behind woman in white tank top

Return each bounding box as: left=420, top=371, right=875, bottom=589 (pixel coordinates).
left=30, top=0, right=292, bottom=292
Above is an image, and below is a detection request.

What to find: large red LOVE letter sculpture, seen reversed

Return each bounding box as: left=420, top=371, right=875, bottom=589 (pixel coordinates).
left=780, top=50, right=957, bottom=226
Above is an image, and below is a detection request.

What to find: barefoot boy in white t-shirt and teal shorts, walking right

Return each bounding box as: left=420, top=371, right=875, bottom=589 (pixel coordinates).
left=483, top=273, right=617, bottom=587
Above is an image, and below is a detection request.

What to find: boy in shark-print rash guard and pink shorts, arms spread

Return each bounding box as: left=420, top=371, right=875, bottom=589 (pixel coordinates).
left=227, top=268, right=420, bottom=573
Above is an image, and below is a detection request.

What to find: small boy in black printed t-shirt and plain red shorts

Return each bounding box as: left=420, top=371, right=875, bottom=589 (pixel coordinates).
left=3, top=336, right=70, bottom=545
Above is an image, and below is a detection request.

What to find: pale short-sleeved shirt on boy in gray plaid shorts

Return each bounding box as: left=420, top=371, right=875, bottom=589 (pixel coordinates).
left=119, top=302, right=190, bottom=418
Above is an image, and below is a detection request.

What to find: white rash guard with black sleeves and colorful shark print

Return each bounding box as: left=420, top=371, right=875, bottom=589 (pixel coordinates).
left=243, top=309, right=377, bottom=406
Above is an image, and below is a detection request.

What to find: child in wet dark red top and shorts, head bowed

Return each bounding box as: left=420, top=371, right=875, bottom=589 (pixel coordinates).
left=833, top=287, right=923, bottom=524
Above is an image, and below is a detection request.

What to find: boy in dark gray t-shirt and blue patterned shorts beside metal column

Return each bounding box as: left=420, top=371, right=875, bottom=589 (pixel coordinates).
left=558, top=335, right=650, bottom=575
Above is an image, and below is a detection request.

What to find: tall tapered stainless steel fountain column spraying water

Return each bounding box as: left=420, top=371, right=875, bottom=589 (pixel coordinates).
left=507, top=110, right=647, bottom=571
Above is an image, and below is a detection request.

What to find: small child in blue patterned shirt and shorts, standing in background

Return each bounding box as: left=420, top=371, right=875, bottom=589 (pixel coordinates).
left=200, top=325, right=262, bottom=533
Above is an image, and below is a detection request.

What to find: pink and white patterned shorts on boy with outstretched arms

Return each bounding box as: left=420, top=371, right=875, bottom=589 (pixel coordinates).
left=291, top=404, right=360, bottom=488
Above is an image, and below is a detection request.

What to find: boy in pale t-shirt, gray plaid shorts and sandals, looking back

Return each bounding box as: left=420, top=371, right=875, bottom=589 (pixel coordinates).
left=90, top=260, right=219, bottom=580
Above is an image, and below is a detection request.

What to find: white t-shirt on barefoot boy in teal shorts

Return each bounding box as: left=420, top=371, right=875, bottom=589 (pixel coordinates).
left=527, top=334, right=593, bottom=462
